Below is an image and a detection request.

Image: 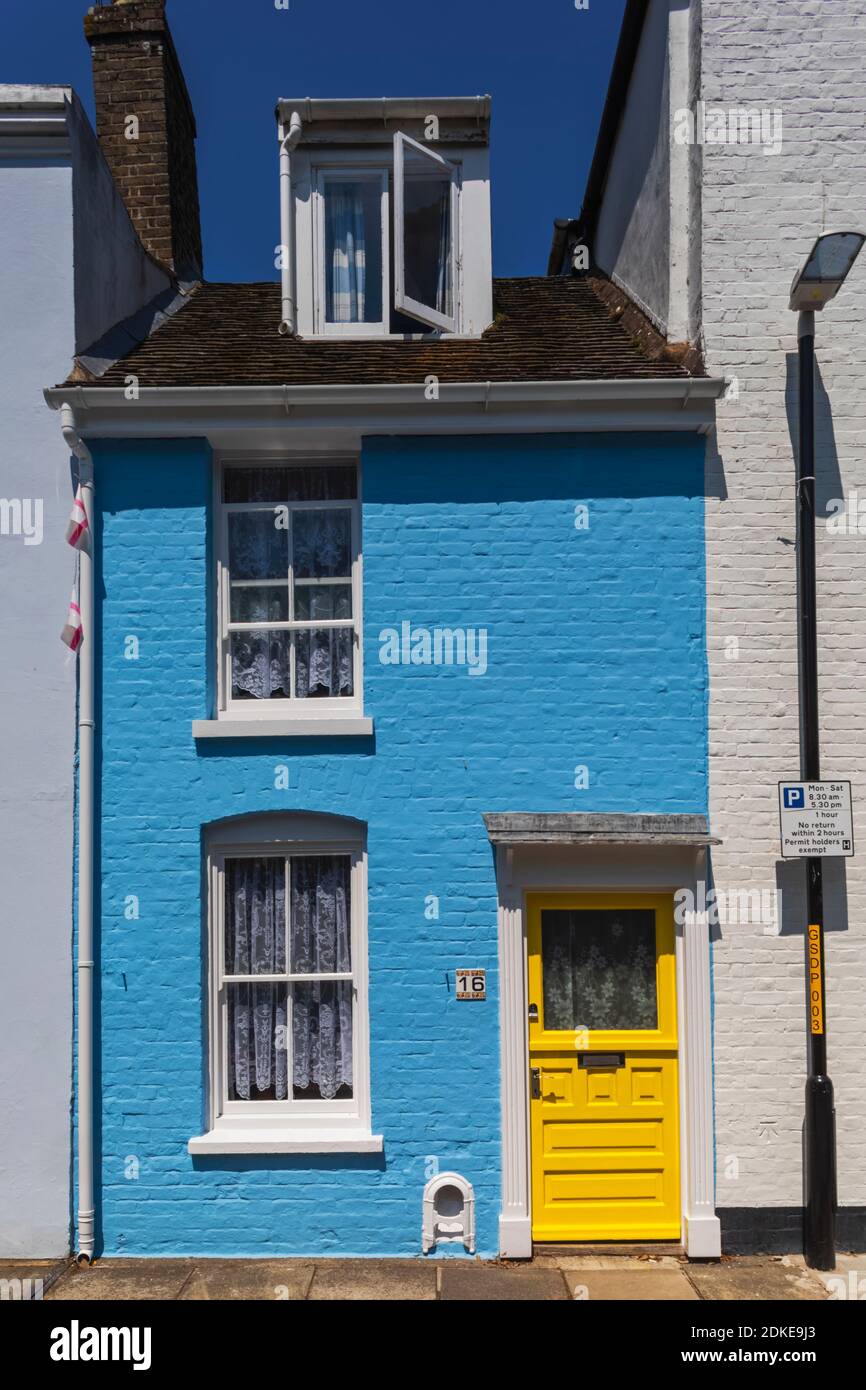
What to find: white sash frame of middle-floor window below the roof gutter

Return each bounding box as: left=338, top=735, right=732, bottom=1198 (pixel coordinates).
left=214, top=452, right=364, bottom=723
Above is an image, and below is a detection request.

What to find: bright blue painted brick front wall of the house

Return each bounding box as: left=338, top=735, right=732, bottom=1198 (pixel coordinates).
left=95, top=435, right=706, bottom=1255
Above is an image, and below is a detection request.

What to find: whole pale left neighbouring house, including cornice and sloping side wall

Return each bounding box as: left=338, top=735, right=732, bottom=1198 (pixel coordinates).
left=0, top=85, right=170, bottom=1258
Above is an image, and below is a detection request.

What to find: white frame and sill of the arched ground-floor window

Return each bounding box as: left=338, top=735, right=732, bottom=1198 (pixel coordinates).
left=189, top=816, right=382, bottom=1154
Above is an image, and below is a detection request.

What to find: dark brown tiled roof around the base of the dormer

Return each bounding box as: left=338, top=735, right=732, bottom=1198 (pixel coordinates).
left=76, top=277, right=695, bottom=388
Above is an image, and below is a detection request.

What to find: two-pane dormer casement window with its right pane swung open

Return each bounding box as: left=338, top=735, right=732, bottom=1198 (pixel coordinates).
left=316, top=132, right=460, bottom=336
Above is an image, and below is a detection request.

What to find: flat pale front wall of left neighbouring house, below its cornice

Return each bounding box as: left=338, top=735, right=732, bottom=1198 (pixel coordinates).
left=0, top=156, right=75, bottom=1258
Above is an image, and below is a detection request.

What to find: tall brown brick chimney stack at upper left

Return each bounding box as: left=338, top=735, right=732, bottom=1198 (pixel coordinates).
left=85, top=0, right=202, bottom=279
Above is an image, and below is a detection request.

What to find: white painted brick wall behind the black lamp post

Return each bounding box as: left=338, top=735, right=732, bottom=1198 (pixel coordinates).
left=702, top=0, right=866, bottom=1207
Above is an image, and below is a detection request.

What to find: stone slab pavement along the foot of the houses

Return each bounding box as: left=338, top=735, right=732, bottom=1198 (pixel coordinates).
left=0, top=1254, right=866, bottom=1302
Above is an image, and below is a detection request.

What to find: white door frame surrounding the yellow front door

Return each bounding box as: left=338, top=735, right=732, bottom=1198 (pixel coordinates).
left=491, top=835, right=721, bottom=1259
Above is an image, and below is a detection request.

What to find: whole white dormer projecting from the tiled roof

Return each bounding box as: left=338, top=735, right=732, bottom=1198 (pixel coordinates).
left=278, top=97, right=492, bottom=338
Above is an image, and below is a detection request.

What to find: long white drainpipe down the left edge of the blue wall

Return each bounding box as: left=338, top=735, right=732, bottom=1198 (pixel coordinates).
left=60, top=404, right=96, bottom=1265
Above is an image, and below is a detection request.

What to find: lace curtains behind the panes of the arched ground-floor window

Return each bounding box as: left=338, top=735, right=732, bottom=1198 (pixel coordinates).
left=224, top=855, right=352, bottom=1101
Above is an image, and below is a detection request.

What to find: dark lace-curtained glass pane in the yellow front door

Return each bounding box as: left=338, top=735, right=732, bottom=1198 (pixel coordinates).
left=541, top=909, right=657, bottom=1031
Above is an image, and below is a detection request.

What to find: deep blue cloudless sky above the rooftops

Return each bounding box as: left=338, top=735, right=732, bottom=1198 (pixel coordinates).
left=0, top=0, right=624, bottom=279
